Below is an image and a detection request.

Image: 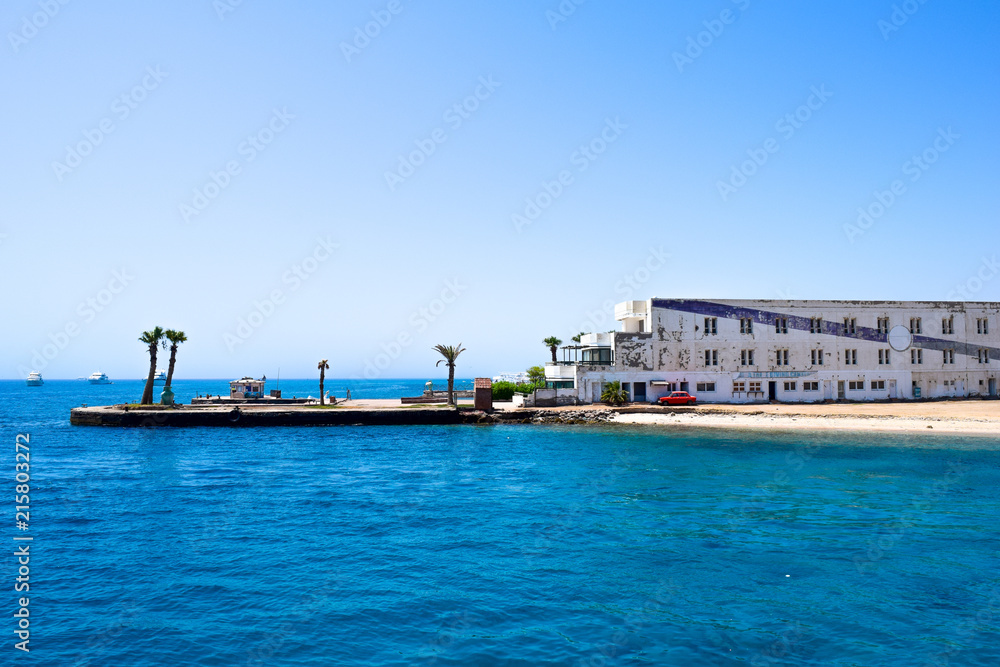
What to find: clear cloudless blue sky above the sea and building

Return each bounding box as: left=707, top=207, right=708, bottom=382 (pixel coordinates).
left=0, top=0, right=1000, bottom=379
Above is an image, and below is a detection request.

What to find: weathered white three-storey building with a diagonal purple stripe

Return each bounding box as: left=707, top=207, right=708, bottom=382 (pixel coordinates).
left=545, top=299, right=1000, bottom=403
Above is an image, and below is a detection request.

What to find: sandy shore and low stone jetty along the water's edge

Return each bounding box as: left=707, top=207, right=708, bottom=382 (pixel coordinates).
left=70, top=399, right=1000, bottom=439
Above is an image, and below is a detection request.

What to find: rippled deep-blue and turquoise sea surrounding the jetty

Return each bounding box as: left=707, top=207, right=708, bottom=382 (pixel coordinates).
left=0, top=380, right=1000, bottom=667
